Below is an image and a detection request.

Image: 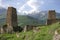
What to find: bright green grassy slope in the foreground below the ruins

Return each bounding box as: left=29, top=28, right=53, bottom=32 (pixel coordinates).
left=0, top=23, right=60, bottom=40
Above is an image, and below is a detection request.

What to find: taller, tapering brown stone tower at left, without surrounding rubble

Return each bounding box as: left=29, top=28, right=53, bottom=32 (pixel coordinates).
left=6, top=7, right=18, bottom=32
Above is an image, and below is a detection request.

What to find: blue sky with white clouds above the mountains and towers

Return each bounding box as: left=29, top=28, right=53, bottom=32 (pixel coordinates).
left=0, top=0, right=60, bottom=14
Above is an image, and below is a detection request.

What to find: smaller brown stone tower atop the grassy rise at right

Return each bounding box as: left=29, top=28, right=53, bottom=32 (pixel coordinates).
left=46, top=10, right=56, bottom=25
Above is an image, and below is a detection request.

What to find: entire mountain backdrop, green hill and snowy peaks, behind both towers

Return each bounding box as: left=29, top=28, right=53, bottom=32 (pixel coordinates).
left=0, top=7, right=60, bottom=25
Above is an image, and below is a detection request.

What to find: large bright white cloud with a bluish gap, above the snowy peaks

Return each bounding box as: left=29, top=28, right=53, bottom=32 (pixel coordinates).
left=18, top=0, right=44, bottom=13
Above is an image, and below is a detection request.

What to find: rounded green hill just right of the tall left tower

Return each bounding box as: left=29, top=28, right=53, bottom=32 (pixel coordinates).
left=18, top=16, right=38, bottom=26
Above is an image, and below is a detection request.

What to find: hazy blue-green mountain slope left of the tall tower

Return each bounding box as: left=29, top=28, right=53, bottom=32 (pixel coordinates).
left=0, top=7, right=7, bottom=26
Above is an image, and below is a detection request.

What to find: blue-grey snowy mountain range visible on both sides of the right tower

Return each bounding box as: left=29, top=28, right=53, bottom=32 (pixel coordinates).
left=28, top=11, right=60, bottom=20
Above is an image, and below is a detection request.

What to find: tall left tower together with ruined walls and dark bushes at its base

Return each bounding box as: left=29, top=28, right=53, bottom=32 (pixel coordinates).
left=0, top=7, right=22, bottom=33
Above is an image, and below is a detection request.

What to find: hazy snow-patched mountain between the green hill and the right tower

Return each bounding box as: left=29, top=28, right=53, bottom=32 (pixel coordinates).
left=28, top=11, right=47, bottom=20
